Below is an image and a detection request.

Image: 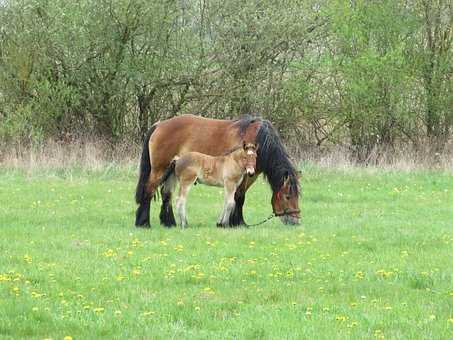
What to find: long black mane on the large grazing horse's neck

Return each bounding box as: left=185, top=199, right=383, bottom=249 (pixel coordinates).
left=256, top=120, right=299, bottom=195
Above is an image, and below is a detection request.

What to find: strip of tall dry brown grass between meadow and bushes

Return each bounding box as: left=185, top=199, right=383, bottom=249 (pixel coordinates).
left=0, top=140, right=453, bottom=171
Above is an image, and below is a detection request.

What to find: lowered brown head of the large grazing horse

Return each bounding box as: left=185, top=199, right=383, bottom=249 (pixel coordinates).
left=272, top=176, right=300, bottom=225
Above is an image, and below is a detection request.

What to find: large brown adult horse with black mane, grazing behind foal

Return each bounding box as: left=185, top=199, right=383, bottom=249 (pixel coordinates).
left=135, top=115, right=300, bottom=228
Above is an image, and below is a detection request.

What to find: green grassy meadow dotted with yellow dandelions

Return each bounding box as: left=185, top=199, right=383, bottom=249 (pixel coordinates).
left=0, top=165, right=453, bottom=339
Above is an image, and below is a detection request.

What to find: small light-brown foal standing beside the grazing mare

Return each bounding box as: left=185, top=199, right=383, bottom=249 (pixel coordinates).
left=163, top=141, right=257, bottom=228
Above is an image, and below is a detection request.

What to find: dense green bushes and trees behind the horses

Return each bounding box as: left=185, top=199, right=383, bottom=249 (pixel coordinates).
left=0, top=0, right=453, bottom=155
